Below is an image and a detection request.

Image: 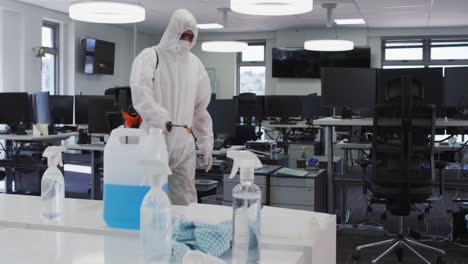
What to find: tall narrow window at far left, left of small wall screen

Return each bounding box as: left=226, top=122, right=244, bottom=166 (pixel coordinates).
left=41, top=22, right=59, bottom=95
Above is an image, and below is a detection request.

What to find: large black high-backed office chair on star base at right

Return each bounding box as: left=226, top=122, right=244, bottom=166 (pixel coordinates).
left=353, top=77, right=445, bottom=263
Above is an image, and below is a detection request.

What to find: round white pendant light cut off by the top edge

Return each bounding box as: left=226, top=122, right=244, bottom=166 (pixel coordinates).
left=231, top=0, right=314, bottom=16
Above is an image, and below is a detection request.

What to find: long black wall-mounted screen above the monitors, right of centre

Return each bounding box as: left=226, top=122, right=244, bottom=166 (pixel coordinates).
left=272, top=47, right=370, bottom=78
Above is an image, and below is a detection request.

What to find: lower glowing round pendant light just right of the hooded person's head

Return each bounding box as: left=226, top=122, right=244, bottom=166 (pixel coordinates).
left=202, top=8, right=249, bottom=53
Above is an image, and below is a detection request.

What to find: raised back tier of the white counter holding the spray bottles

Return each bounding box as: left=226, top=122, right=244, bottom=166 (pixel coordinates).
left=0, top=194, right=336, bottom=264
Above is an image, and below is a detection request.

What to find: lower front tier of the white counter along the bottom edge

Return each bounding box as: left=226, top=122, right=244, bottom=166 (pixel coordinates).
left=0, top=228, right=306, bottom=264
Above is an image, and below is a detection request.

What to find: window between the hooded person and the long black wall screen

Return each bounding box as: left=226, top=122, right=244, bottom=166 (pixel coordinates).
left=237, top=43, right=266, bottom=95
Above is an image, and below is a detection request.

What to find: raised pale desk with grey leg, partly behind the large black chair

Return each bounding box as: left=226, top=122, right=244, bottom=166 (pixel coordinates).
left=314, top=117, right=468, bottom=213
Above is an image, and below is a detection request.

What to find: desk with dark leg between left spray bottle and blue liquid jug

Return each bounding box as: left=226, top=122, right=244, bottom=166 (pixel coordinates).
left=65, top=143, right=105, bottom=200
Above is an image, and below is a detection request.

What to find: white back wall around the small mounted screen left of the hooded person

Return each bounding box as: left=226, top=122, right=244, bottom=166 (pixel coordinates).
left=75, top=22, right=156, bottom=95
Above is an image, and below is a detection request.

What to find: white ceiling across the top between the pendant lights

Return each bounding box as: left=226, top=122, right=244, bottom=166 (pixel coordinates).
left=13, top=0, right=468, bottom=33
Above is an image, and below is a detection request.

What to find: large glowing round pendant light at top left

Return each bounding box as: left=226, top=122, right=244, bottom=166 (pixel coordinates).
left=68, top=1, right=145, bottom=24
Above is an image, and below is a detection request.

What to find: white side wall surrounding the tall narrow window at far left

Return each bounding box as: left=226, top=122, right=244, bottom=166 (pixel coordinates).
left=0, top=0, right=74, bottom=92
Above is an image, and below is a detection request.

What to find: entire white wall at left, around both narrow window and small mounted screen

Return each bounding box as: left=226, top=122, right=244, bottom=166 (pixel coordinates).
left=0, top=0, right=159, bottom=94
